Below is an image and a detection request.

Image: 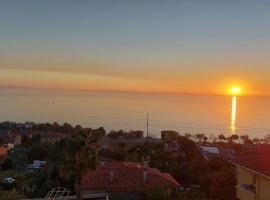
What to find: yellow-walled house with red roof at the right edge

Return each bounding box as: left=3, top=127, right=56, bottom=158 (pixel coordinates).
left=229, top=147, right=270, bottom=200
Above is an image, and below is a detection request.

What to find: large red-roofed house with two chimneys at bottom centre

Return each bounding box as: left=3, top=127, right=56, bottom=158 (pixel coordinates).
left=81, top=162, right=180, bottom=200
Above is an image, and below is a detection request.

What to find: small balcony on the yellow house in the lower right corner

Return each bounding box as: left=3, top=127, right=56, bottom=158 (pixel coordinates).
left=237, top=184, right=256, bottom=200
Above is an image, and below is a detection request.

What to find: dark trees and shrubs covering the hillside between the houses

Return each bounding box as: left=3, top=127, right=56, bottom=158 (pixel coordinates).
left=0, top=122, right=270, bottom=200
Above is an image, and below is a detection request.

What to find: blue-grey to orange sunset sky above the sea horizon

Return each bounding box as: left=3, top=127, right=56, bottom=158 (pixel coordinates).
left=0, top=0, right=270, bottom=95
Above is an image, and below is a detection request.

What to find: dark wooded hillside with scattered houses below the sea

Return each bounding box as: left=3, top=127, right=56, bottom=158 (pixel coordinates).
left=0, top=122, right=270, bottom=200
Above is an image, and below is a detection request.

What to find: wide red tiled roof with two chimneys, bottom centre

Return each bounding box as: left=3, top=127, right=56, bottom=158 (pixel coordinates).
left=82, top=162, right=180, bottom=192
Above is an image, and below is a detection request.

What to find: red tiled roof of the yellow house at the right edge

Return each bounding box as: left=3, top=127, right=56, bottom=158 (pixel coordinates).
left=230, top=147, right=270, bottom=177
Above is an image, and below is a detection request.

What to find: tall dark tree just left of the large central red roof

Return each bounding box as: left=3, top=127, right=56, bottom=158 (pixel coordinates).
left=49, top=131, right=99, bottom=199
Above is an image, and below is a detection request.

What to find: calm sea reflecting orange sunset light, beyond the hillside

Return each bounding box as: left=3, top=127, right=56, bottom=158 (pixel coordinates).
left=0, top=89, right=270, bottom=137
